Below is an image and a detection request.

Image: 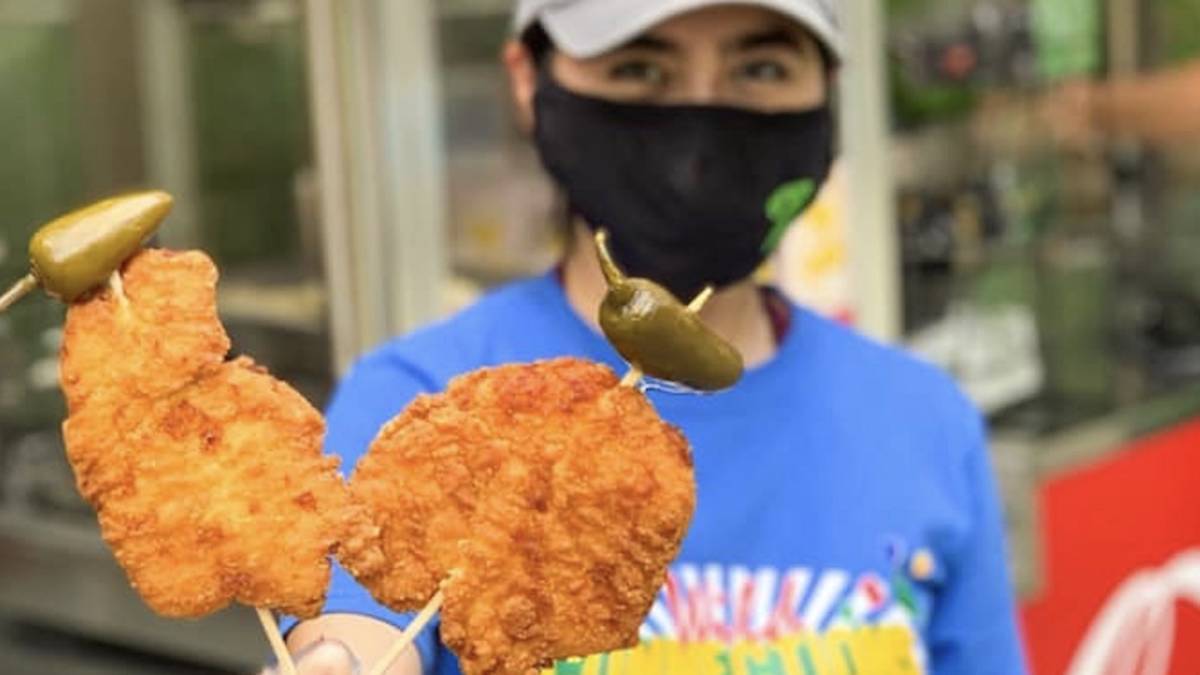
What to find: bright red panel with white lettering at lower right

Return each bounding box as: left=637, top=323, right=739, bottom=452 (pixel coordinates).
left=1022, top=420, right=1200, bottom=675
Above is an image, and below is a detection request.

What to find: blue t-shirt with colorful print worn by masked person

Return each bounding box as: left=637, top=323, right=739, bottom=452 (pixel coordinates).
left=307, top=275, right=1025, bottom=675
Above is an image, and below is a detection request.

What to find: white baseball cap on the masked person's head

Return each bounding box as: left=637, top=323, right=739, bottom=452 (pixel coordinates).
left=514, top=0, right=842, bottom=60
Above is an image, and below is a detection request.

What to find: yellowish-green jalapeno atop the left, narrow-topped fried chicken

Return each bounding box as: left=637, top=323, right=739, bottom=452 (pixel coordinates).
left=0, top=191, right=173, bottom=311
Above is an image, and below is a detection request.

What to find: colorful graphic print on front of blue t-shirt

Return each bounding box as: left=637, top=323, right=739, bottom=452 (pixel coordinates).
left=546, top=565, right=926, bottom=675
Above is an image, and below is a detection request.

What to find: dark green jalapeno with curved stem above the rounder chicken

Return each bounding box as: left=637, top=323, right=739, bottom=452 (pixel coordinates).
left=596, top=229, right=743, bottom=392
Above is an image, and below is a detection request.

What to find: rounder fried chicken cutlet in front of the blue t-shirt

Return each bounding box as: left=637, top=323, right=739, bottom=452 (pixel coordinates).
left=350, top=359, right=695, bottom=675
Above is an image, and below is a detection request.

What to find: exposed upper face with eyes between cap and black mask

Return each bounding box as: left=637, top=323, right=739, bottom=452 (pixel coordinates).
left=551, top=5, right=828, bottom=112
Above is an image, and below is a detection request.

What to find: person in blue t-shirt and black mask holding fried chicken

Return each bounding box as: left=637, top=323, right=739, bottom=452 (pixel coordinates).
left=276, top=0, right=1024, bottom=675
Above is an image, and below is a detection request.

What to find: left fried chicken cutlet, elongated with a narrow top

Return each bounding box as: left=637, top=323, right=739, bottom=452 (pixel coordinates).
left=61, top=251, right=383, bottom=617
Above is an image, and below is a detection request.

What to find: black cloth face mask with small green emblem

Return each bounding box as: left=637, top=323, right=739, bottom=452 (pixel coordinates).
left=534, top=76, right=834, bottom=301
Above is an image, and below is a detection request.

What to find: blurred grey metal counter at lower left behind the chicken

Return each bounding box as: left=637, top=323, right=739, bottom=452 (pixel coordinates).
left=0, top=514, right=262, bottom=675
